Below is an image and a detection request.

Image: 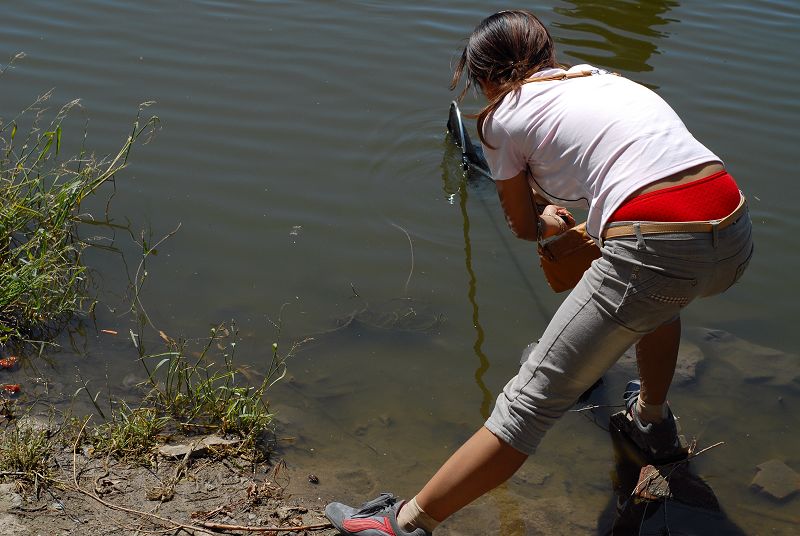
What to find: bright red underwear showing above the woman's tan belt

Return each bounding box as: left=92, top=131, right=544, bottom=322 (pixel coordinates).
left=608, top=170, right=740, bottom=223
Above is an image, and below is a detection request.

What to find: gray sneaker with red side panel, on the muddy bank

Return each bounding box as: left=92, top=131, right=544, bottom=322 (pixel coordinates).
left=325, top=493, right=431, bottom=536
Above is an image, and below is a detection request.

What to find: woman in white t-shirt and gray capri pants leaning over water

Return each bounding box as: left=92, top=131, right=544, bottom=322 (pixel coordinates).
left=326, top=11, right=752, bottom=536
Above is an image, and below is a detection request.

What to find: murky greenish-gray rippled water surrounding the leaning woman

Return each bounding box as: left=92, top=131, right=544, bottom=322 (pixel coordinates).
left=0, top=0, right=800, bottom=534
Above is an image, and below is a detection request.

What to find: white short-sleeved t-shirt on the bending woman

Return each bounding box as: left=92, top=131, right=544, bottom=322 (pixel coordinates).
left=484, top=65, right=721, bottom=237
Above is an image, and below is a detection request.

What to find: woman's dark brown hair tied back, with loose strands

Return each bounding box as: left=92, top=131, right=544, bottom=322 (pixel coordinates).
left=450, top=10, right=559, bottom=147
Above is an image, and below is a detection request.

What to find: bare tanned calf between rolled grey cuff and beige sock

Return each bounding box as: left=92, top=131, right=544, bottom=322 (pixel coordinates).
left=417, top=427, right=528, bottom=521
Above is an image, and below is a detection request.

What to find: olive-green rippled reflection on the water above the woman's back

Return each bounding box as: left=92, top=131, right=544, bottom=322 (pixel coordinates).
left=552, top=0, right=679, bottom=73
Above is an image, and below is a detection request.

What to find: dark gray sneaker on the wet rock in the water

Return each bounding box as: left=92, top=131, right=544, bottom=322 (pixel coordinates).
left=611, top=380, right=689, bottom=465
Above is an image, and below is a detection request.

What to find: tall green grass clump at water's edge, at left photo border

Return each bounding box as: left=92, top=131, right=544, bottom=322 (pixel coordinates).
left=0, top=82, right=158, bottom=344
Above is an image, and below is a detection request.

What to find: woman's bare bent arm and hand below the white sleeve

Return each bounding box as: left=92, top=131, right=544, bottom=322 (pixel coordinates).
left=495, top=170, right=575, bottom=242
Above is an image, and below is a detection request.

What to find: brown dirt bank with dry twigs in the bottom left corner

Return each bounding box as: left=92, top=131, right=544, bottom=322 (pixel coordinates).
left=0, top=448, right=338, bottom=536
